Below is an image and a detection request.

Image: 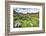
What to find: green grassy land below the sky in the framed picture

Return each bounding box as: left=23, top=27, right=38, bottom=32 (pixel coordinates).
left=13, top=13, right=39, bottom=28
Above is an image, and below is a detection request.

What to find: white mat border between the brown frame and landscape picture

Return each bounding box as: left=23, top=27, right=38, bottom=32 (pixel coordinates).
left=10, top=5, right=42, bottom=32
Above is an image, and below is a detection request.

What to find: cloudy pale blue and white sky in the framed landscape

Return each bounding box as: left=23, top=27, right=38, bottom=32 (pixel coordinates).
left=13, top=8, right=39, bottom=13
